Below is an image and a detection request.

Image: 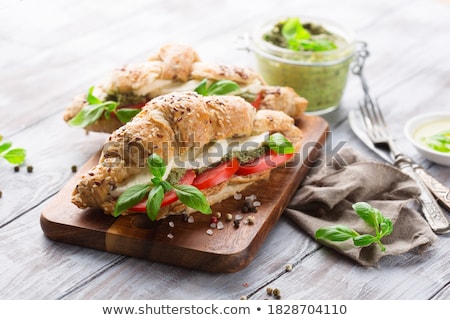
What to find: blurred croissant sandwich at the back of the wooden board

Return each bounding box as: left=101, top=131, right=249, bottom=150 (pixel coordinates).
left=63, top=44, right=307, bottom=133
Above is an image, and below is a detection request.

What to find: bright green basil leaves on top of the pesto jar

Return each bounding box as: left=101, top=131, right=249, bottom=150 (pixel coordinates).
left=281, top=18, right=336, bottom=51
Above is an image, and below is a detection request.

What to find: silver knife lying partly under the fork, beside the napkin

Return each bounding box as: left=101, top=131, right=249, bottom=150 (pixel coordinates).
left=348, top=110, right=450, bottom=215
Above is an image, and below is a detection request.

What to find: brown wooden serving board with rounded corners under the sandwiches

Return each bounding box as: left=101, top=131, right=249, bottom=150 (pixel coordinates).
left=40, top=115, right=328, bottom=272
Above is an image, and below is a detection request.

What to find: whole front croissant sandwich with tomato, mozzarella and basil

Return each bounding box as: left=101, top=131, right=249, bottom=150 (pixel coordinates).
left=72, top=92, right=302, bottom=220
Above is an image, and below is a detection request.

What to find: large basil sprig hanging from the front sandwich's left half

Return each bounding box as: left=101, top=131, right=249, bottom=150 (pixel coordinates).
left=113, top=153, right=212, bottom=221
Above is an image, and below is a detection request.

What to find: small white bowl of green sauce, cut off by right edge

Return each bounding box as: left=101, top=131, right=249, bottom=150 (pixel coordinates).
left=405, top=112, right=450, bottom=166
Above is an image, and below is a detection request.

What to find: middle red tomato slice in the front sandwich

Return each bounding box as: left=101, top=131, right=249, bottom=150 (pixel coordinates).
left=192, top=158, right=243, bottom=189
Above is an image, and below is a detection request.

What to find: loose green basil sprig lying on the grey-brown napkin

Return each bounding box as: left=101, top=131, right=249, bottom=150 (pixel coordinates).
left=315, top=202, right=394, bottom=251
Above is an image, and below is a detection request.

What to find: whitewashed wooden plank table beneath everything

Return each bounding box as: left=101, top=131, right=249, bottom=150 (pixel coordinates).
left=0, top=0, right=450, bottom=300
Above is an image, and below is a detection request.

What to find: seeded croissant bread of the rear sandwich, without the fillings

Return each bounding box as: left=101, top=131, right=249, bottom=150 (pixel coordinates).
left=63, top=44, right=308, bottom=133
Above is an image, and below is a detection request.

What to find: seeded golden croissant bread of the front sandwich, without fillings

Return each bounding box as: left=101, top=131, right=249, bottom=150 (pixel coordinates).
left=72, top=92, right=302, bottom=219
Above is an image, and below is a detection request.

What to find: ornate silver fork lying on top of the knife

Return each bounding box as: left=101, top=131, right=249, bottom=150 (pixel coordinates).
left=359, top=77, right=450, bottom=234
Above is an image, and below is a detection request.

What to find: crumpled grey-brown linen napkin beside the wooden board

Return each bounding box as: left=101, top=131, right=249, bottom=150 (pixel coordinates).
left=284, top=147, right=437, bottom=266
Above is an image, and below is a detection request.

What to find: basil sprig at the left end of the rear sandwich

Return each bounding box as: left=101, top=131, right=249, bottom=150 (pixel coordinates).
left=68, top=86, right=141, bottom=128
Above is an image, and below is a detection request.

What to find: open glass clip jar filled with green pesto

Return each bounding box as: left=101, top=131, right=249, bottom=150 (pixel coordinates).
left=250, top=16, right=355, bottom=115
